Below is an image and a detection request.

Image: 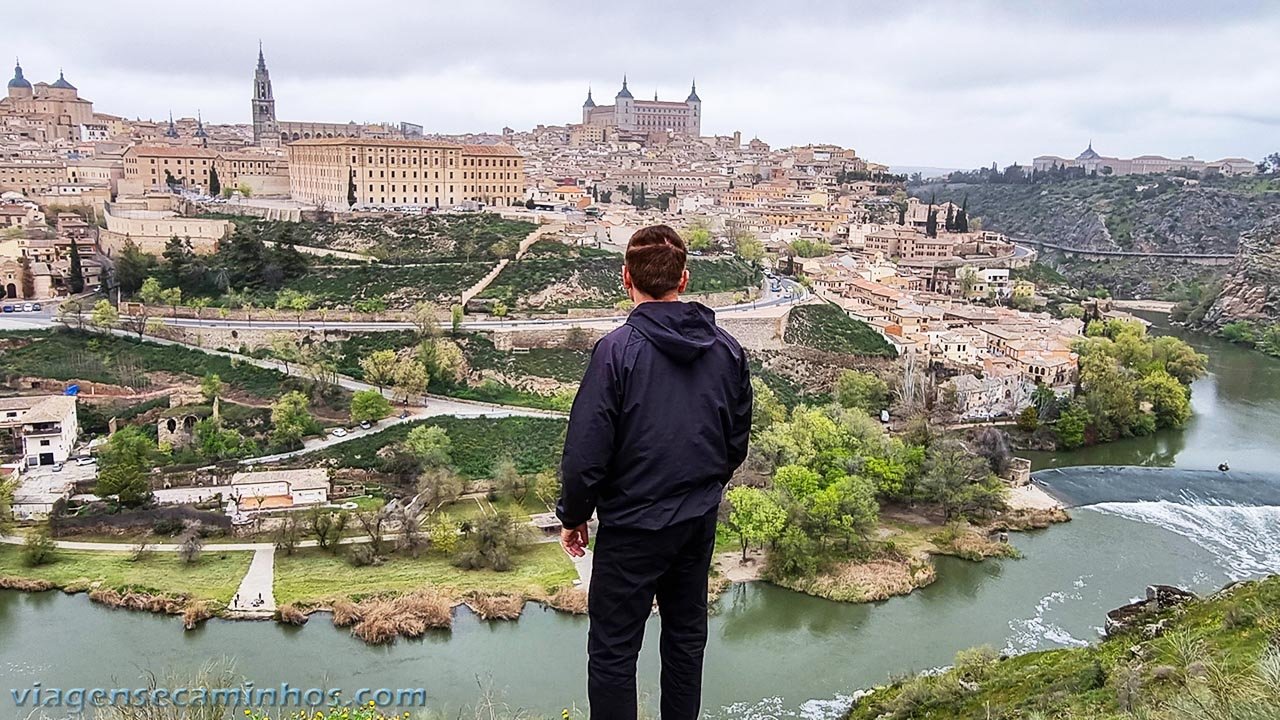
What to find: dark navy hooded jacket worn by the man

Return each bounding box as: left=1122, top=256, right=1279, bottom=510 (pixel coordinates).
left=556, top=297, right=751, bottom=529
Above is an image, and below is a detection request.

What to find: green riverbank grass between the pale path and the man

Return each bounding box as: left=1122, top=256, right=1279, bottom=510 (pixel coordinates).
left=275, top=543, right=577, bottom=603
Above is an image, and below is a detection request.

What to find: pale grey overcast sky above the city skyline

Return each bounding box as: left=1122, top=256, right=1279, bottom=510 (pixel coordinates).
left=10, top=0, right=1280, bottom=168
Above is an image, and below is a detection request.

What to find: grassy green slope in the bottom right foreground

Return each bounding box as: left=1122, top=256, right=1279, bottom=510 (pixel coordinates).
left=847, top=577, right=1280, bottom=720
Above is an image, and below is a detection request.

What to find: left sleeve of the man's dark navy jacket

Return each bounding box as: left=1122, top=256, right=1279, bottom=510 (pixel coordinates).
left=556, top=342, right=621, bottom=528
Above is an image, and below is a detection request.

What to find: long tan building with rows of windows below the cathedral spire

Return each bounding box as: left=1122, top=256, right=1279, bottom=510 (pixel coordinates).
left=288, top=137, right=525, bottom=209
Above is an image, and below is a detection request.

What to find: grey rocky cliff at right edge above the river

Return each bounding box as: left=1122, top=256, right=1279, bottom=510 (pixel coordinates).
left=1198, top=215, right=1280, bottom=328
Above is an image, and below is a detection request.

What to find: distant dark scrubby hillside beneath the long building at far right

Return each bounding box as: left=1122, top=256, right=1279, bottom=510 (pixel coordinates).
left=910, top=176, right=1280, bottom=252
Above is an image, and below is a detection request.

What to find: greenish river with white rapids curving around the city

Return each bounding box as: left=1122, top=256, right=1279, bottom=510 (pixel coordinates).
left=0, top=320, right=1280, bottom=720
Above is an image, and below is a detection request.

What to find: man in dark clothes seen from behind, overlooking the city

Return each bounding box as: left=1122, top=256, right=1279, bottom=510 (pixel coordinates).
left=557, top=225, right=751, bottom=720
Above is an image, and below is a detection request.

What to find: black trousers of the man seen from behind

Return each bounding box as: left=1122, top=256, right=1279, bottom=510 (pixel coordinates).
left=586, top=512, right=716, bottom=720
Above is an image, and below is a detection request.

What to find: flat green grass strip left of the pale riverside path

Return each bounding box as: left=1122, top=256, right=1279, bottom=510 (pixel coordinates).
left=0, top=544, right=252, bottom=602
